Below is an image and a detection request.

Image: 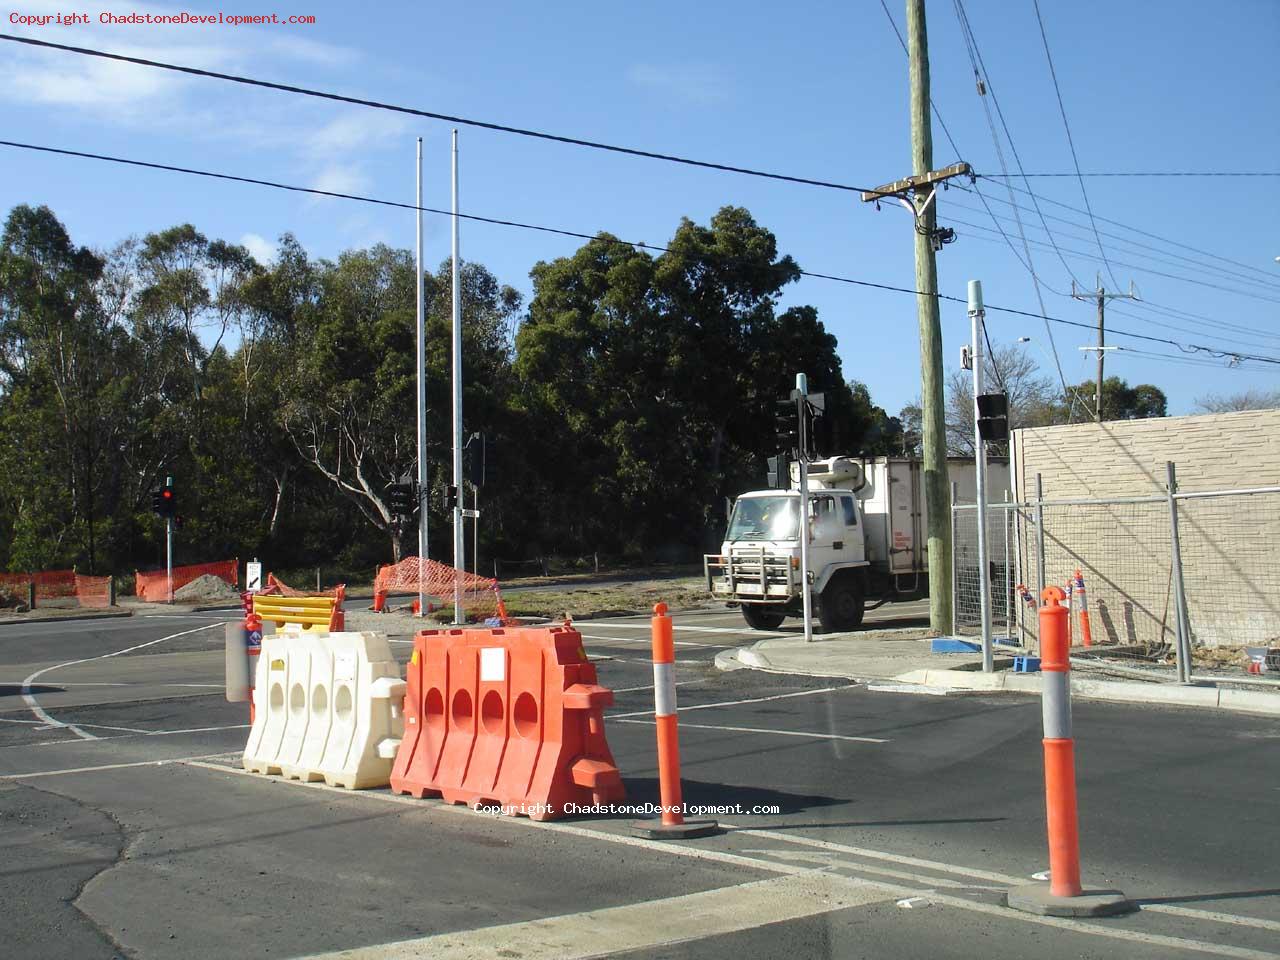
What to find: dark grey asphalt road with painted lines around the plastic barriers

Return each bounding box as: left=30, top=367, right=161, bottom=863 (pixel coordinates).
left=0, top=611, right=1280, bottom=960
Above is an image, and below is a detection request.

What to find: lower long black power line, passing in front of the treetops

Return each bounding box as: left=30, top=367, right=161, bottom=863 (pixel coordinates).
left=0, top=140, right=1280, bottom=365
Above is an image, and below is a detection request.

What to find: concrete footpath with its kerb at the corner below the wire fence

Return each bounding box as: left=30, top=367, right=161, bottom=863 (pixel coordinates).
left=716, top=630, right=1280, bottom=716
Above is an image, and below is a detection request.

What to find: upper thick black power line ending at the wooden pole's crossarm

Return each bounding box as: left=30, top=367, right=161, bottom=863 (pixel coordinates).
left=0, top=33, right=869, bottom=193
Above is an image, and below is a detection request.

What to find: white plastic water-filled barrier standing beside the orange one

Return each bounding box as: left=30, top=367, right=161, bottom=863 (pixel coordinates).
left=243, top=628, right=404, bottom=790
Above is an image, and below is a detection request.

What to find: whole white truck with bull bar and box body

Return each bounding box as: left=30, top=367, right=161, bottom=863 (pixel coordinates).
left=703, top=457, right=1009, bottom=632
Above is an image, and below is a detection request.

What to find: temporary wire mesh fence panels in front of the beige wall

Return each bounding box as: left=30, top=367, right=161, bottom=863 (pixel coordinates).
left=951, top=466, right=1280, bottom=687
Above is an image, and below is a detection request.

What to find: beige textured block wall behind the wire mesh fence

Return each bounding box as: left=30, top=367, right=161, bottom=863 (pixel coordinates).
left=1011, top=410, right=1280, bottom=646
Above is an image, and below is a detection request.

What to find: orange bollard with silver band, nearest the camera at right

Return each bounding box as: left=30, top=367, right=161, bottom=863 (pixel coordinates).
left=1006, top=586, right=1133, bottom=916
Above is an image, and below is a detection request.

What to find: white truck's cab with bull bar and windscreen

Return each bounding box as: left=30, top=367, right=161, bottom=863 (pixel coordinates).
left=703, top=457, right=869, bottom=632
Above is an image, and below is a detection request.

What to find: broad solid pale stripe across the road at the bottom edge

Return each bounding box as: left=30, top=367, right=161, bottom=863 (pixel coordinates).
left=296, top=874, right=892, bottom=960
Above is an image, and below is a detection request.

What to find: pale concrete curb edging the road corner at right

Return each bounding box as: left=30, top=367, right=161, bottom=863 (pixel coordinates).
left=716, top=645, right=1280, bottom=717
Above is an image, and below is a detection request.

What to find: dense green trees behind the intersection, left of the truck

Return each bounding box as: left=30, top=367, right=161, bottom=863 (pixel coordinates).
left=0, top=206, right=952, bottom=573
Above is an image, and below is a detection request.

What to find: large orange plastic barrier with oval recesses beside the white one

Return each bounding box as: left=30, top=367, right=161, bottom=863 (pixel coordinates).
left=390, top=625, right=626, bottom=820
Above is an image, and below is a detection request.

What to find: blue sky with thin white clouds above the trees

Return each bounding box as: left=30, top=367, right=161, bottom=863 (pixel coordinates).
left=0, top=0, right=1280, bottom=413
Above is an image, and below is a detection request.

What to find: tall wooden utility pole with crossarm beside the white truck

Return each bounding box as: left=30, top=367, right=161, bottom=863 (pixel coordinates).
left=861, top=0, right=970, bottom=634
